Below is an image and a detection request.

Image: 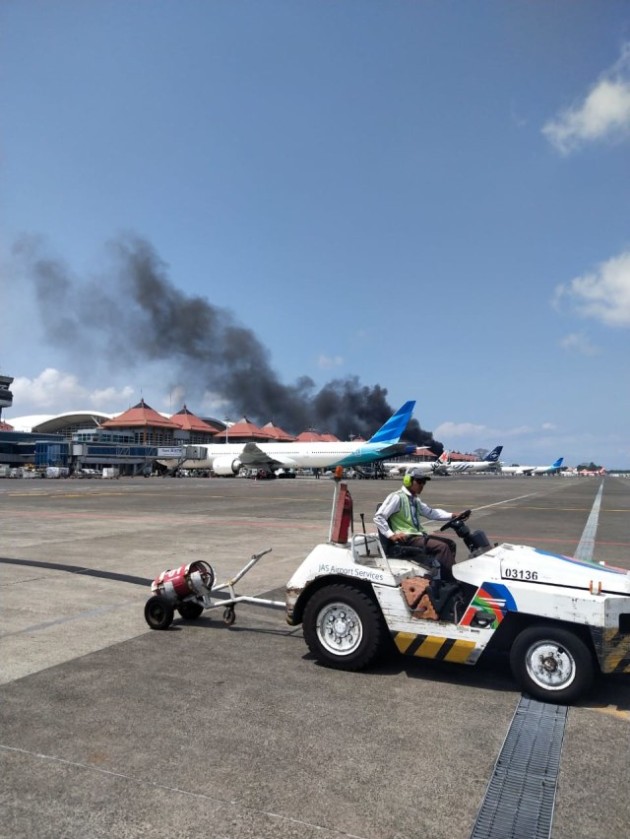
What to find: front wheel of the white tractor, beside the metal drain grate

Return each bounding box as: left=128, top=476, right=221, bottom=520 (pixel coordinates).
left=510, top=625, right=595, bottom=705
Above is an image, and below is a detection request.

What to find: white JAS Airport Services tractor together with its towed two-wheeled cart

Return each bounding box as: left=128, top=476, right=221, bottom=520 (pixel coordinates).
left=145, top=480, right=630, bottom=704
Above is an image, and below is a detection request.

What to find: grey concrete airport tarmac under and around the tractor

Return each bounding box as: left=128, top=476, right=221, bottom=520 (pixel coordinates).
left=0, top=476, right=630, bottom=839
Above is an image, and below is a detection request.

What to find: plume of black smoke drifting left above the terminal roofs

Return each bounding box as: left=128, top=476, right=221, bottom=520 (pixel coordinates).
left=14, top=235, right=443, bottom=453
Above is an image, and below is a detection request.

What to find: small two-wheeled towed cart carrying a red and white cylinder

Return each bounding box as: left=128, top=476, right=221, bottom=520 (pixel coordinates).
left=144, top=548, right=285, bottom=629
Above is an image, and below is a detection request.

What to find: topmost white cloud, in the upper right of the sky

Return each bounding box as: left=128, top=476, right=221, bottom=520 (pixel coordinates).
left=542, top=43, right=630, bottom=154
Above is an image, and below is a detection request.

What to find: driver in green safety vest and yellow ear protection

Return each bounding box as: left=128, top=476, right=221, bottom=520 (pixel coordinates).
left=374, top=469, right=466, bottom=581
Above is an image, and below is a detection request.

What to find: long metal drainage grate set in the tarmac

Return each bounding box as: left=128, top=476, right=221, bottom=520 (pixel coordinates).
left=470, top=697, right=568, bottom=839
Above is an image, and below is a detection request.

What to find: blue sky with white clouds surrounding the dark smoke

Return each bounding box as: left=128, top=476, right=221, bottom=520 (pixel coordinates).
left=0, top=0, right=630, bottom=468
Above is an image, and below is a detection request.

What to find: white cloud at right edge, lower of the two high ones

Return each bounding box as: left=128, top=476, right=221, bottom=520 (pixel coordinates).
left=555, top=251, right=630, bottom=327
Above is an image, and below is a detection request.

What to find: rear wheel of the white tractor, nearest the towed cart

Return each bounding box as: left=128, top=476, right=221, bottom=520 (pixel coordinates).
left=302, top=584, right=386, bottom=670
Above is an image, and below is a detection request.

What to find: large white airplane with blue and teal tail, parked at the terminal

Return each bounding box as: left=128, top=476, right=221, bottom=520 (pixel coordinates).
left=183, top=400, right=416, bottom=477
